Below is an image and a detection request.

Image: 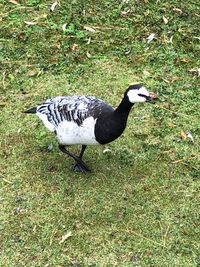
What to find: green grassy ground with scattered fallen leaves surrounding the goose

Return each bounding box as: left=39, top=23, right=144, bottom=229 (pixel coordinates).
left=0, top=0, right=200, bottom=267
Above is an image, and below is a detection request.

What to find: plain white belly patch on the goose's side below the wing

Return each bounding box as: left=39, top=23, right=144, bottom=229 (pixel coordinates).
left=56, top=117, right=99, bottom=145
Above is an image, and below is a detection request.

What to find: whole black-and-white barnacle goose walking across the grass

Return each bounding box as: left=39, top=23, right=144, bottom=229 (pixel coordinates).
left=24, top=84, right=157, bottom=173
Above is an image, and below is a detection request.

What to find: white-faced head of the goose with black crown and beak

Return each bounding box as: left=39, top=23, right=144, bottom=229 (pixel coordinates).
left=125, top=84, right=158, bottom=104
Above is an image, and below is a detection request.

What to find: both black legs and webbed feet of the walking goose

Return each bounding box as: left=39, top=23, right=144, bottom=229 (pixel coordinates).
left=59, top=145, right=90, bottom=172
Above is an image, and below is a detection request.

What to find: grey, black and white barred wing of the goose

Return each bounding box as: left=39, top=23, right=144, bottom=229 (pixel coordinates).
left=36, top=96, right=106, bottom=131
